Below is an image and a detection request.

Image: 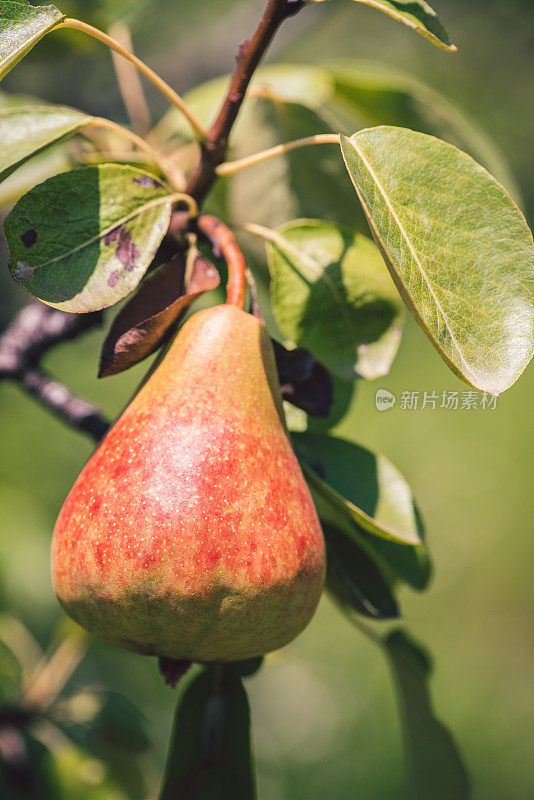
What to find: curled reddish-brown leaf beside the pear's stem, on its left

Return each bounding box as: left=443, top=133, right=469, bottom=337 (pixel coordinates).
left=99, top=254, right=221, bottom=378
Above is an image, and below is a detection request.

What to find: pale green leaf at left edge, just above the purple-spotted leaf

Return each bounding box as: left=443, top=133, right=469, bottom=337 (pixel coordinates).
left=0, top=106, right=92, bottom=181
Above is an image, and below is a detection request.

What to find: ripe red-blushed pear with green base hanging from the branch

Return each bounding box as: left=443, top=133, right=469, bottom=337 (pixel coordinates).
left=52, top=305, right=325, bottom=662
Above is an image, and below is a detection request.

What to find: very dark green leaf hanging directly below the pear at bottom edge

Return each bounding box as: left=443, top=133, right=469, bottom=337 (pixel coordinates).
left=160, top=666, right=256, bottom=800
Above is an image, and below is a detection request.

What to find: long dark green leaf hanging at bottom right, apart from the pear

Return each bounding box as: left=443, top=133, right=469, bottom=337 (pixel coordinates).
left=384, top=630, right=471, bottom=800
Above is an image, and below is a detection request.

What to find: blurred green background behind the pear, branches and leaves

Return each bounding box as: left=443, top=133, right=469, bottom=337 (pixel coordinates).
left=0, top=0, right=534, bottom=800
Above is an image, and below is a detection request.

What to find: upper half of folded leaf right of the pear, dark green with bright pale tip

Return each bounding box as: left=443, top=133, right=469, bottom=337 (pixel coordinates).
left=298, top=432, right=423, bottom=549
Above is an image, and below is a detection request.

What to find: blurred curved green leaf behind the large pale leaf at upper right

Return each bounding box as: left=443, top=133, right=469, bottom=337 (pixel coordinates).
left=325, top=59, right=521, bottom=203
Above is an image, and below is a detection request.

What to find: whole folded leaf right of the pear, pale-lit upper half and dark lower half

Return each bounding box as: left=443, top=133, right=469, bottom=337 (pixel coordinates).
left=292, top=432, right=431, bottom=589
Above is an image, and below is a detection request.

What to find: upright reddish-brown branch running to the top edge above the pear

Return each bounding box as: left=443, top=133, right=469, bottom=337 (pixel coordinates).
left=186, top=0, right=305, bottom=203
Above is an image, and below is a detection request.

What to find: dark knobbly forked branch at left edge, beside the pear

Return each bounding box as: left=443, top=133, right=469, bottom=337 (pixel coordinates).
left=0, top=302, right=108, bottom=442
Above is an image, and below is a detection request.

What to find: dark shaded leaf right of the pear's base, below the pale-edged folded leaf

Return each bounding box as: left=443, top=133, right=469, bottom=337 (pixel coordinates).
left=323, top=525, right=399, bottom=619
